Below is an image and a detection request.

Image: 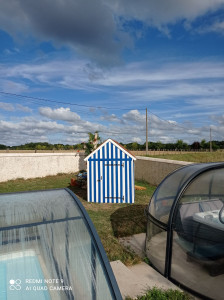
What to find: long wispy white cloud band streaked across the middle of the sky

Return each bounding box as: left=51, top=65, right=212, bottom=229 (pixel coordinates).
left=0, top=60, right=224, bottom=105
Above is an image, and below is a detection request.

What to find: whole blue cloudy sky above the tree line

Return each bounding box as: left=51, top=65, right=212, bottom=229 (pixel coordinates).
left=0, top=0, right=224, bottom=146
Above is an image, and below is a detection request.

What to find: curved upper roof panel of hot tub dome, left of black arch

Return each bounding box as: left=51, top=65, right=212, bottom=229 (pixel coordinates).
left=148, top=162, right=224, bottom=225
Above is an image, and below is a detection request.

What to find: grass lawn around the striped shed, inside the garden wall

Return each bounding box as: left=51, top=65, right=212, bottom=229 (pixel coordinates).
left=0, top=174, right=156, bottom=265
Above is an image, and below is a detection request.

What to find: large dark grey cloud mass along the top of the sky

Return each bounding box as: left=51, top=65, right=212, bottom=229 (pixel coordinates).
left=0, top=0, right=224, bottom=65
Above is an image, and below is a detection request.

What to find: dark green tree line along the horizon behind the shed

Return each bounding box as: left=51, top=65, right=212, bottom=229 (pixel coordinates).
left=0, top=137, right=224, bottom=151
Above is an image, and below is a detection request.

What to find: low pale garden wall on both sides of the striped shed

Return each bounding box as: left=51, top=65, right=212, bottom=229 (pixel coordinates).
left=0, top=152, right=191, bottom=185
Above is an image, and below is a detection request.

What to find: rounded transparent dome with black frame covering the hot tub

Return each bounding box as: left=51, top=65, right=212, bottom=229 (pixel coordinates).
left=146, top=162, right=224, bottom=299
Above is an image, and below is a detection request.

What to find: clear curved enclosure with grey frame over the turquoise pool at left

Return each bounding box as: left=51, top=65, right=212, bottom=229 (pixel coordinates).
left=0, top=189, right=122, bottom=300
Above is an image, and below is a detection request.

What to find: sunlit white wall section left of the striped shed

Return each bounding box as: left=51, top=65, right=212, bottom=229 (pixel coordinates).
left=0, top=153, right=86, bottom=182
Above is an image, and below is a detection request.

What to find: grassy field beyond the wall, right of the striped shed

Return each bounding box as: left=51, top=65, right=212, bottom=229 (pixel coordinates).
left=147, top=151, right=224, bottom=163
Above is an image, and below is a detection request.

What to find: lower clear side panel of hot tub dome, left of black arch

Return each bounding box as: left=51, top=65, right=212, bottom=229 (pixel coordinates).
left=146, top=220, right=167, bottom=274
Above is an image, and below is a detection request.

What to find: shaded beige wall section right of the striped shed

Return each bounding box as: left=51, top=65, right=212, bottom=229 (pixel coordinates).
left=135, top=156, right=192, bottom=185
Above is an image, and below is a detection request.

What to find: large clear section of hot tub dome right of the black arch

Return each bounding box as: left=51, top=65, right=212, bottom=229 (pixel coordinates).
left=171, top=169, right=224, bottom=299
